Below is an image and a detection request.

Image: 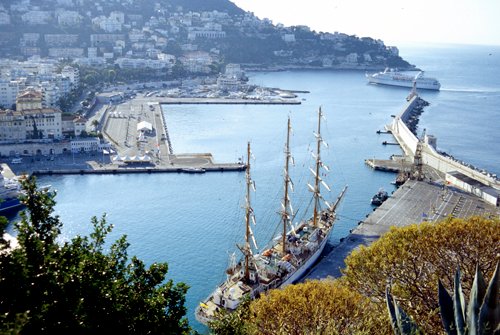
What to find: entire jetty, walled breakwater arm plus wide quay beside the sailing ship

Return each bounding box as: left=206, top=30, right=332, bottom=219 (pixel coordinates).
left=302, top=93, right=500, bottom=280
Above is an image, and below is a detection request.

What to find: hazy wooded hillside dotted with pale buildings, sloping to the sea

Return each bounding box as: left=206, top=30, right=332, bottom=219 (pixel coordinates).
left=0, top=0, right=412, bottom=69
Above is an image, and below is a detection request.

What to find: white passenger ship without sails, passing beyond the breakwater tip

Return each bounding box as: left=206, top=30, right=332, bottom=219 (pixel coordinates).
left=366, top=68, right=441, bottom=91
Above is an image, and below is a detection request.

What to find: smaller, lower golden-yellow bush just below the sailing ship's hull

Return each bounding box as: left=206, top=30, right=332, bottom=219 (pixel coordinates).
left=210, top=280, right=390, bottom=335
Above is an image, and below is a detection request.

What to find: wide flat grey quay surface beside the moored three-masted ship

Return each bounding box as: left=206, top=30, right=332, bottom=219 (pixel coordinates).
left=303, top=180, right=500, bottom=280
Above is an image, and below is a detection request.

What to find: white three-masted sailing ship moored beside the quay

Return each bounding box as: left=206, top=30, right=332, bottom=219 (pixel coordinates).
left=195, top=108, right=347, bottom=324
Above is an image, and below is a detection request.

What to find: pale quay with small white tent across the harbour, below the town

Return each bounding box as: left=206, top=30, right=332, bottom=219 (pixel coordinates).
left=84, top=97, right=250, bottom=174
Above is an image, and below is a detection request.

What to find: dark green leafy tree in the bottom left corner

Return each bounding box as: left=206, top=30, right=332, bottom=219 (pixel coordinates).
left=0, top=177, right=190, bottom=334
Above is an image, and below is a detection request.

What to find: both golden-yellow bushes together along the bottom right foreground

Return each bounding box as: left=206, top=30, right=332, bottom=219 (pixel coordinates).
left=210, top=217, right=500, bottom=335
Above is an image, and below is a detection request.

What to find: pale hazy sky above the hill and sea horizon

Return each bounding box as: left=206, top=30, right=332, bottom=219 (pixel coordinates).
left=231, top=0, right=500, bottom=45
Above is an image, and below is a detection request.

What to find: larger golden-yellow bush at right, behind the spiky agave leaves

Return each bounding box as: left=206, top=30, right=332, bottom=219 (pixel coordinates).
left=344, top=217, right=500, bottom=334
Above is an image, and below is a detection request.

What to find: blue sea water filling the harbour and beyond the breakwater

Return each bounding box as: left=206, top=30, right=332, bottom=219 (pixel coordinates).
left=4, top=44, right=500, bottom=333
